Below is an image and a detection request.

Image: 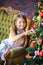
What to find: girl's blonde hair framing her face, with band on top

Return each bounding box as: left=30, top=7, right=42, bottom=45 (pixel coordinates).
left=13, top=12, right=27, bottom=29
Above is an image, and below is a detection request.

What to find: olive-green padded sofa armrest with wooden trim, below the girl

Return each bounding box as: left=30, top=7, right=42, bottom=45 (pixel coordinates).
left=4, top=46, right=27, bottom=65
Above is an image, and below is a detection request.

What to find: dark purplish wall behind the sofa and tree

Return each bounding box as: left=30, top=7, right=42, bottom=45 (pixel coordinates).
left=0, top=0, right=38, bottom=19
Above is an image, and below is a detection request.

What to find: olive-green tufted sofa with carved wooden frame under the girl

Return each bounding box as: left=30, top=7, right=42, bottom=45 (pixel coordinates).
left=0, top=6, right=31, bottom=65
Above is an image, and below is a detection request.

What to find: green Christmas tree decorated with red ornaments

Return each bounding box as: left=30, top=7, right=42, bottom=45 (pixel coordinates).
left=25, top=0, right=43, bottom=65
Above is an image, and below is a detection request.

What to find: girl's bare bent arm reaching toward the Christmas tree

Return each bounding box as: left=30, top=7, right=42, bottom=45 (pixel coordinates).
left=10, top=27, right=32, bottom=42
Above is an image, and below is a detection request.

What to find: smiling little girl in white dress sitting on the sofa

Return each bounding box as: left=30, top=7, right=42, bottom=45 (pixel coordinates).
left=0, top=13, right=33, bottom=61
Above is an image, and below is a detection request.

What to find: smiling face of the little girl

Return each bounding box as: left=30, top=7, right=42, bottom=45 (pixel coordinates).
left=15, top=17, right=26, bottom=30
